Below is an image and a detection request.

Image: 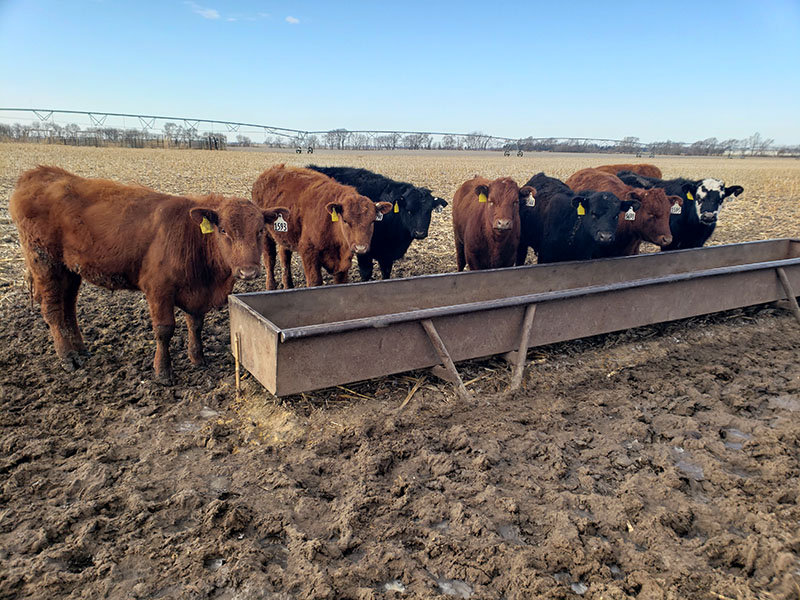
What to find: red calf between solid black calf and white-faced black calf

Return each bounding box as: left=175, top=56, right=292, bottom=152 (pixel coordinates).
left=564, top=169, right=683, bottom=256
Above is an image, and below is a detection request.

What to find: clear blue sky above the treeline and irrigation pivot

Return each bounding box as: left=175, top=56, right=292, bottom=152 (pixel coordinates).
left=0, top=0, right=800, bottom=144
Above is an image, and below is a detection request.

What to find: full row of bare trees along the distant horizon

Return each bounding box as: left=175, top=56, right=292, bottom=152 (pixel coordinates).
left=0, top=121, right=800, bottom=157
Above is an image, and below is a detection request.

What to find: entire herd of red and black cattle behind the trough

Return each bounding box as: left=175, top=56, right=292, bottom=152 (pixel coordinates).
left=10, top=164, right=743, bottom=382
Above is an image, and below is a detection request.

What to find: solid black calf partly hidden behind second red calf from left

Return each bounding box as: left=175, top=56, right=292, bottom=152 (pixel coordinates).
left=308, top=165, right=447, bottom=281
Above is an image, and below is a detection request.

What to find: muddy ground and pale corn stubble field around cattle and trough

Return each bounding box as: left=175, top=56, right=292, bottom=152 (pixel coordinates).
left=0, top=144, right=800, bottom=599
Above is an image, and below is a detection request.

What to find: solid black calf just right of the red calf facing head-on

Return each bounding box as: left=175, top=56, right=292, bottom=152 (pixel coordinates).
left=517, top=173, right=641, bottom=265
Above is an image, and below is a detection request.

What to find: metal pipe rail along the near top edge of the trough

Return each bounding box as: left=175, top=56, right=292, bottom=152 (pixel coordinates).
left=280, top=258, right=800, bottom=342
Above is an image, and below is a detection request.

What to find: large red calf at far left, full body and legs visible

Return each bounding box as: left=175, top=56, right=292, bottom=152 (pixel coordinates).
left=9, top=166, right=289, bottom=383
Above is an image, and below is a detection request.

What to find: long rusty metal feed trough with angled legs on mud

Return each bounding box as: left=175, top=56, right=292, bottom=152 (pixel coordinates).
left=229, top=239, right=800, bottom=396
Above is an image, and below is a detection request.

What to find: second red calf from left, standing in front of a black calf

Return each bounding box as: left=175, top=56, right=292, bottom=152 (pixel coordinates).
left=252, top=164, right=392, bottom=290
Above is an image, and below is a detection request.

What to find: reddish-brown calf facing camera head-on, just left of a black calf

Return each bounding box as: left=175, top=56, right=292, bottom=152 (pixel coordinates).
left=453, top=176, right=536, bottom=271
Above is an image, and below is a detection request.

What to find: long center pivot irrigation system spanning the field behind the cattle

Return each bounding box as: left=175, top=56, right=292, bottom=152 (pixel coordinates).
left=0, top=108, right=649, bottom=156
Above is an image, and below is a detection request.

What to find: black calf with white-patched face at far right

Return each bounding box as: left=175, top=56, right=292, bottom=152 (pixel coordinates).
left=617, top=171, right=744, bottom=250
